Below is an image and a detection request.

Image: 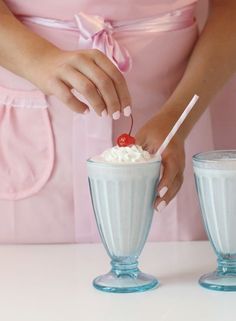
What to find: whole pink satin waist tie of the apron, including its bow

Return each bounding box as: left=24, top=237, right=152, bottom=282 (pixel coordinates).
left=18, top=4, right=195, bottom=72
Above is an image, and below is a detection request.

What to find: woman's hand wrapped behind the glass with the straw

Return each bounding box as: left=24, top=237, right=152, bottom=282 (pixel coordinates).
left=136, top=109, right=185, bottom=212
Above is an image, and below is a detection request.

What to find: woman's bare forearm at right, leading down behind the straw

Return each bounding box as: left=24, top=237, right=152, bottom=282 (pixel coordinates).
left=164, top=0, right=236, bottom=137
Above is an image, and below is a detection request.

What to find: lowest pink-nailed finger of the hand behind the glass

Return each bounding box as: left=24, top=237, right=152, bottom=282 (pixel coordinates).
left=154, top=173, right=183, bottom=212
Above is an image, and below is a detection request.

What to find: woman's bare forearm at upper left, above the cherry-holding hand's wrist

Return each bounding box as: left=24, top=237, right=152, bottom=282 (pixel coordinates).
left=0, top=1, right=57, bottom=80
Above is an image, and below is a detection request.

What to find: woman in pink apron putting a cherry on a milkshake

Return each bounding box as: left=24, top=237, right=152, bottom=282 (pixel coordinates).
left=0, top=0, right=236, bottom=243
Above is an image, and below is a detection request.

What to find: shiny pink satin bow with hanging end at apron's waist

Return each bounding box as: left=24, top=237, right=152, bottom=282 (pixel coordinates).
left=75, top=12, right=131, bottom=72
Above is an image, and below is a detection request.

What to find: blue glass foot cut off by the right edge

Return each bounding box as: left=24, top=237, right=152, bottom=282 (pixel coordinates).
left=199, top=271, right=236, bottom=291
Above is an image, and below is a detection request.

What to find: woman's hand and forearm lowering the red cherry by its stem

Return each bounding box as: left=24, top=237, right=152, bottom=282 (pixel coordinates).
left=0, top=5, right=131, bottom=119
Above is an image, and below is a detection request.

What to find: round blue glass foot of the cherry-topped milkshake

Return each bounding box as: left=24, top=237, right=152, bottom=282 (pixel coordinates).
left=93, top=270, right=159, bottom=293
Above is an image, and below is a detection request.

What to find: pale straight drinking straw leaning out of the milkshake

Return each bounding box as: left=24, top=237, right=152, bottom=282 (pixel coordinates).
left=156, top=95, right=199, bottom=156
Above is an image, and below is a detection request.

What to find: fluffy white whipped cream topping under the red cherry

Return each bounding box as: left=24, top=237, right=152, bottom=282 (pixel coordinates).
left=92, top=145, right=158, bottom=164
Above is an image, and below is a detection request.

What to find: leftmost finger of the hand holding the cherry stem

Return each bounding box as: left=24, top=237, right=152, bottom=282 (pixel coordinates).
left=52, top=80, right=89, bottom=114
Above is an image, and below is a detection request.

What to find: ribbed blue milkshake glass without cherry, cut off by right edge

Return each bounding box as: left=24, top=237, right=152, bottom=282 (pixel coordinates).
left=193, top=150, right=236, bottom=291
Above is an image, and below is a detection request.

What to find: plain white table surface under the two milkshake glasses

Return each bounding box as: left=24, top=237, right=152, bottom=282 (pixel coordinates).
left=0, top=242, right=236, bottom=321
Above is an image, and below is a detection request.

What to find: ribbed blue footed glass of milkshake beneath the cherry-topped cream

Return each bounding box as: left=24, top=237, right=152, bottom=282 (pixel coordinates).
left=87, top=160, right=160, bottom=293
